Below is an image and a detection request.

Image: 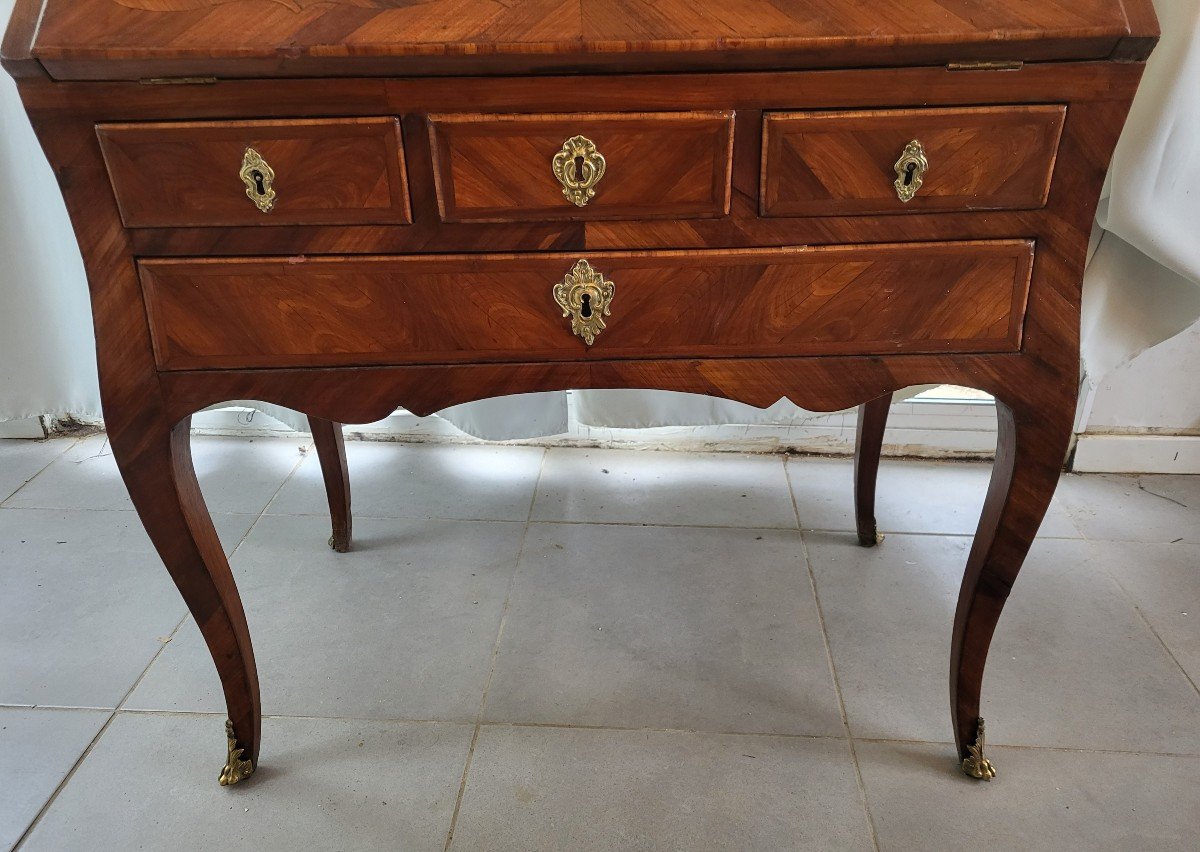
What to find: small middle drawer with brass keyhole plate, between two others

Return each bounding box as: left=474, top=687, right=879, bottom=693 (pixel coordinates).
left=428, top=112, right=733, bottom=222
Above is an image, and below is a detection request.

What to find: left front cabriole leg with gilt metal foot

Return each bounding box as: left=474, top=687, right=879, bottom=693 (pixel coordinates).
left=109, top=418, right=262, bottom=785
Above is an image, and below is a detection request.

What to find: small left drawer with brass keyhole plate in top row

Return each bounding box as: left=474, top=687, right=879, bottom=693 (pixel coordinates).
left=96, top=118, right=412, bottom=228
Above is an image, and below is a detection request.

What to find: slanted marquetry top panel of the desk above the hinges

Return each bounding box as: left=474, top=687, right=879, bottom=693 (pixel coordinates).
left=8, top=0, right=1153, bottom=79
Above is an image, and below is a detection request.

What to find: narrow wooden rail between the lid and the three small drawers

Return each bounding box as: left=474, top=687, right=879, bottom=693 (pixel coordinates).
left=14, top=62, right=1142, bottom=118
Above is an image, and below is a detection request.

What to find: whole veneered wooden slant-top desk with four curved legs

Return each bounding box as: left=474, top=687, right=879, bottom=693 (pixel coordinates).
left=4, top=0, right=1157, bottom=784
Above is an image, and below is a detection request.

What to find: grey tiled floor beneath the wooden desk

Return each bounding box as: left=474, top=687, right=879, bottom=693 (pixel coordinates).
left=0, top=437, right=1200, bottom=852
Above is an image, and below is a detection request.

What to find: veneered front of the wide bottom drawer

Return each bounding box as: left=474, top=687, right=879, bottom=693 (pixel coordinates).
left=140, top=240, right=1033, bottom=370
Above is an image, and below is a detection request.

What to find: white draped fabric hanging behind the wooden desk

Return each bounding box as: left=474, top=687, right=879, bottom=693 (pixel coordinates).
left=0, top=0, right=1200, bottom=439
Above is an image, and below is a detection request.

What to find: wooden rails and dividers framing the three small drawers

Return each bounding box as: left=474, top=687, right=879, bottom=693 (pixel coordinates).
left=4, top=62, right=1141, bottom=257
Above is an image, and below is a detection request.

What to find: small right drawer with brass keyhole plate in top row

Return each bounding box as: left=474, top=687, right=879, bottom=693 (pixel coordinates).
left=761, top=106, right=1067, bottom=216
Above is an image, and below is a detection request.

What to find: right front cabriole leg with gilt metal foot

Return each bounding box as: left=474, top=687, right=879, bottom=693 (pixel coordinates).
left=950, top=394, right=1074, bottom=780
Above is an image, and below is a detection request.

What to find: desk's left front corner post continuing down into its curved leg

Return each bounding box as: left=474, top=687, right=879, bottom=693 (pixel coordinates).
left=21, top=107, right=262, bottom=779
